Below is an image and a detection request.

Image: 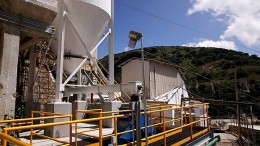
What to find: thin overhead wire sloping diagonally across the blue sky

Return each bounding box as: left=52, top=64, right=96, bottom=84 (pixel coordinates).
left=115, top=1, right=260, bottom=53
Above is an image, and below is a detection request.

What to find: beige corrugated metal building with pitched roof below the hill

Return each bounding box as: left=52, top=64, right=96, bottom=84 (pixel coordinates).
left=119, top=58, right=184, bottom=99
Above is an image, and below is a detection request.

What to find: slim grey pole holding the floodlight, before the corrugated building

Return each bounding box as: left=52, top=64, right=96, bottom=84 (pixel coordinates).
left=141, top=37, right=148, bottom=145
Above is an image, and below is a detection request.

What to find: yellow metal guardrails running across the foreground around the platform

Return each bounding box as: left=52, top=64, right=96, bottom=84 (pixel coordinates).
left=0, top=103, right=210, bottom=146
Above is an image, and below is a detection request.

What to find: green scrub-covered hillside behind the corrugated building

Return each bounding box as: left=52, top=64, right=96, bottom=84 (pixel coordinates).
left=100, top=46, right=260, bottom=116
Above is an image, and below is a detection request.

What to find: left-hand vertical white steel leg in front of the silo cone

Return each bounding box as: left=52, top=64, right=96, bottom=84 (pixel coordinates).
left=55, top=0, right=65, bottom=102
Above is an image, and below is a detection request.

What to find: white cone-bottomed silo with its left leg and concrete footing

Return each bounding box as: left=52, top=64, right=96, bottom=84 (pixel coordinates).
left=44, top=0, right=113, bottom=137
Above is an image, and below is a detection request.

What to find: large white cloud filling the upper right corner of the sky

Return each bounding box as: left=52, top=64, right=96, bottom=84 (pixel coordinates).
left=188, top=0, right=260, bottom=46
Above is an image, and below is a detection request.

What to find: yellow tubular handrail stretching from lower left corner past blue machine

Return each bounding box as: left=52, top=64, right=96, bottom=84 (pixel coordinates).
left=0, top=103, right=210, bottom=146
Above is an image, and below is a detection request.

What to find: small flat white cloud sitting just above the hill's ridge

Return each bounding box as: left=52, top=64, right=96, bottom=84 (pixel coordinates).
left=182, top=40, right=236, bottom=50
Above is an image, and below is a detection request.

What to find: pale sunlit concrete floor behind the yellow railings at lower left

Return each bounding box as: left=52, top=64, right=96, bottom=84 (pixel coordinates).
left=20, top=123, right=114, bottom=146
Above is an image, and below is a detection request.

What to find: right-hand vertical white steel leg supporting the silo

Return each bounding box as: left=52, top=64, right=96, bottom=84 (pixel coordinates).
left=109, top=0, right=115, bottom=101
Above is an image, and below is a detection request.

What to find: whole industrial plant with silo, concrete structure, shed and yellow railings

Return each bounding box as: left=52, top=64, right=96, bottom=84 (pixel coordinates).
left=0, top=0, right=259, bottom=146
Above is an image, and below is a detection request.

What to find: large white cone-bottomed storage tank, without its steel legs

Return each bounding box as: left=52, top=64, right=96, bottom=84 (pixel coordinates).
left=51, top=0, right=111, bottom=74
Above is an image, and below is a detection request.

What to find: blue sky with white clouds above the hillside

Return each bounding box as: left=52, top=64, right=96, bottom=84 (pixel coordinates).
left=99, top=0, right=260, bottom=58
